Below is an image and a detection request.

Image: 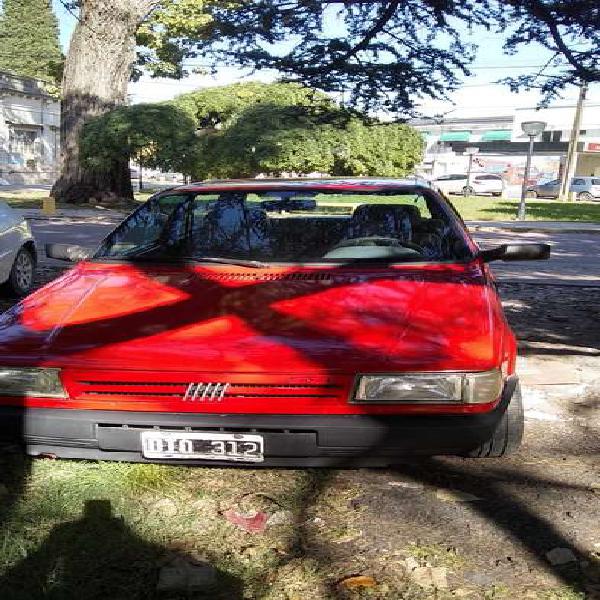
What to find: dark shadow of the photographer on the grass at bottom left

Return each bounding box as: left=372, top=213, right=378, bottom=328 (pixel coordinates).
left=0, top=500, right=242, bottom=600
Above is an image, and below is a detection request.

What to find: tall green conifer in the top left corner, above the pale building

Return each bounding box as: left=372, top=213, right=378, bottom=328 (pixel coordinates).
left=0, top=0, right=63, bottom=82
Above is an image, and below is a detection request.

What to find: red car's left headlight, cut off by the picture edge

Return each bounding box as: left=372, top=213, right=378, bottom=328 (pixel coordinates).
left=0, top=367, right=67, bottom=398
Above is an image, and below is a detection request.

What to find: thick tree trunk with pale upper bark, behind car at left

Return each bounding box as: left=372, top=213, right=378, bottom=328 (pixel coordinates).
left=52, top=0, right=157, bottom=203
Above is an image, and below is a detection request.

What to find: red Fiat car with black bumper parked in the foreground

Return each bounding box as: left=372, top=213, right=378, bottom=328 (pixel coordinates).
left=0, top=179, right=549, bottom=466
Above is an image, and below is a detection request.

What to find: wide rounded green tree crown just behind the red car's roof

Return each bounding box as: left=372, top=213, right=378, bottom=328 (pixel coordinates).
left=110, top=83, right=423, bottom=179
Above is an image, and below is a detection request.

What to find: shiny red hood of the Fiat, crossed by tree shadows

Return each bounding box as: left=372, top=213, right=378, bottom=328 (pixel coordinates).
left=0, top=262, right=502, bottom=373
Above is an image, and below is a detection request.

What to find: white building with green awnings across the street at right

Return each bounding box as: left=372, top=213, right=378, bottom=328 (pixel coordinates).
left=410, top=102, right=600, bottom=185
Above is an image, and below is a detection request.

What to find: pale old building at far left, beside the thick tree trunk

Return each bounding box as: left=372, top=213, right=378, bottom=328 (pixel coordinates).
left=0, top=71, right=60, bottom=184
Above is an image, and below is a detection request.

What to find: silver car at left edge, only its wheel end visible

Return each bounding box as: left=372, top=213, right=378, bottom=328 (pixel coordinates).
left=0, top=201, right=37, bottom=296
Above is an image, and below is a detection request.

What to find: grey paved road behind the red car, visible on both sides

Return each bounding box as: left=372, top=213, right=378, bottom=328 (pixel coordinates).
left=31, top=218, right=600, bottom=286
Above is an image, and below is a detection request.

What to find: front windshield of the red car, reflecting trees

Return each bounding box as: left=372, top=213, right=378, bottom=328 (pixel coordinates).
left=96, top=187, right=471, bottom=263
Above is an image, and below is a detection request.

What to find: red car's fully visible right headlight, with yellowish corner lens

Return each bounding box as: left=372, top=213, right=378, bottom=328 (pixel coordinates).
left=353, top=369, right=502, bottom=404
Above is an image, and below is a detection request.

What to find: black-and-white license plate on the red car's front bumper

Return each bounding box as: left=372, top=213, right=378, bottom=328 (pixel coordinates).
left=141, top=431, right=264, bottom=462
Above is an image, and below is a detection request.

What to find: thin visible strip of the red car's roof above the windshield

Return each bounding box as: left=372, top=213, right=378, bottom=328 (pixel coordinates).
left=162, top=177, right=433, bottom=193
